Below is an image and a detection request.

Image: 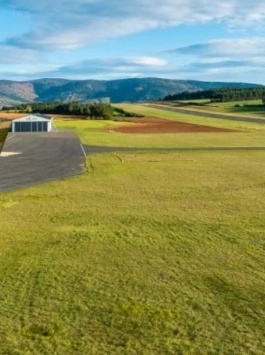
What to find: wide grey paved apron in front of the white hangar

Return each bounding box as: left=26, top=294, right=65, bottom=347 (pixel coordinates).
left=0, top=131, right=85, bottom=192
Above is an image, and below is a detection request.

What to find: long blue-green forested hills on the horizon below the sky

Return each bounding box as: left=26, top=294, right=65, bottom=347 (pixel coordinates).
left=0, top=78, right=261, bottom=106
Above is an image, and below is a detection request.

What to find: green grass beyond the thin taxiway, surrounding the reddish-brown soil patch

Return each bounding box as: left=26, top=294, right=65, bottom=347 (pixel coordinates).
left=56, top=104, right=265, bottom=152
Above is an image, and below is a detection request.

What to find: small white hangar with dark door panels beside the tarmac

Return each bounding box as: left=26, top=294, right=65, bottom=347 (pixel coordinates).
left=11, top=113, right=54, bottom=132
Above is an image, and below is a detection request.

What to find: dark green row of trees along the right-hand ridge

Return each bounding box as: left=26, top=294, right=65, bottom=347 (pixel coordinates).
left=164, top=87, right=265, bottom=102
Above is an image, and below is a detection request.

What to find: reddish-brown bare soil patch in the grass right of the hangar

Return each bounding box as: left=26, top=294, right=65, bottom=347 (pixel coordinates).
left=111, top=117, right=234, bottom=133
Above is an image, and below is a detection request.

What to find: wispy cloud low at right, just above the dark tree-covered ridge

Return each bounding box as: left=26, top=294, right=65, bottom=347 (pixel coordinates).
left=163, top=38, right=265, bottom=82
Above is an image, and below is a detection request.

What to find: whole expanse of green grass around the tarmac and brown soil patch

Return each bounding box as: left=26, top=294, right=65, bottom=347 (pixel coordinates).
left=0, top=106, right=265, bottom=355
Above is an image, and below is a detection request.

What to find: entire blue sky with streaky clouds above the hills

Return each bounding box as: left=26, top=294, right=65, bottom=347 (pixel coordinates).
left=0, top=0, right=265, bottom=85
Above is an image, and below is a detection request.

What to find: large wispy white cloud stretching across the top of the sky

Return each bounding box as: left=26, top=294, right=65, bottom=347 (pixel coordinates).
left=2, top=0, right=265, bottom=50
